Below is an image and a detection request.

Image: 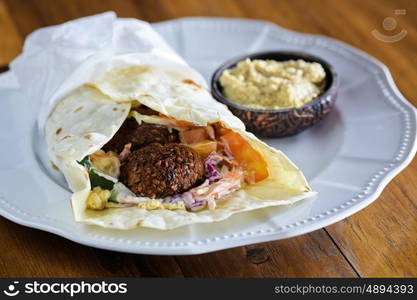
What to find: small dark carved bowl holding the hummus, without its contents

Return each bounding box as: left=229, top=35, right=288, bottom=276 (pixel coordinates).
left=211, top=51, right=339, bottom=137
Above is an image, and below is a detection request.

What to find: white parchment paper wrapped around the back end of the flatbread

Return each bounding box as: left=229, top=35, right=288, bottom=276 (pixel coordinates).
left=10, top=12, right=207, bottom=132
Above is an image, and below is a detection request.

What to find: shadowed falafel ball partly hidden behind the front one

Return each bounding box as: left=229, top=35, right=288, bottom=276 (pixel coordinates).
left=103, top=118, right=179, bottom=153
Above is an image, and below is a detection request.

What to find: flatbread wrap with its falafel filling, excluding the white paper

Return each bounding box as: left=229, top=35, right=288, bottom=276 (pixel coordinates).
left=45, top=65, right=315, bottom=230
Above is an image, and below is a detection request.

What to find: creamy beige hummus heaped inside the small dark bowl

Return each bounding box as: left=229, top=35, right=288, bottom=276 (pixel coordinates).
left=220, top=59, right=326, bottom=109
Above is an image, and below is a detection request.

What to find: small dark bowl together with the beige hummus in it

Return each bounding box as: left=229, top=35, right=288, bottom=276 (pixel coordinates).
left=211, top=51, right=339, bottom=137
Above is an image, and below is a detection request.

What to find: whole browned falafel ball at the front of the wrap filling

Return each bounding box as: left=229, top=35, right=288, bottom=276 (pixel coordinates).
left=120, top=143, right=204, bottom=198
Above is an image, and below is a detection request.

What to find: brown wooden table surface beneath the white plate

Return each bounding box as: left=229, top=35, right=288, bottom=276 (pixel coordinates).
left=0, top=0, right=417, bottom=277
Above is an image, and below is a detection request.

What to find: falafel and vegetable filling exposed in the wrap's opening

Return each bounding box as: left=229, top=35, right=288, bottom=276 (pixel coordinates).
left=79, top=105, right=268, bottom=211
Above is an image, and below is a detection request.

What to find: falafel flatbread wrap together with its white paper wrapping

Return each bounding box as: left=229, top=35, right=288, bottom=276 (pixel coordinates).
left=11, top=12, right=314, bottom=229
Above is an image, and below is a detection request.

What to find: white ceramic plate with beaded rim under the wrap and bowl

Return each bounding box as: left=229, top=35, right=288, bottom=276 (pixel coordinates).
left=0, top=18, right=416, bottom=254
